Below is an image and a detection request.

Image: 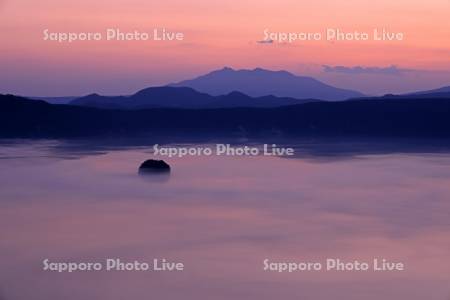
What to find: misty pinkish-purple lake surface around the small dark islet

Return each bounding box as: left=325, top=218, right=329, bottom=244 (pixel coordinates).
left=0, top=141, right=450, bottom=300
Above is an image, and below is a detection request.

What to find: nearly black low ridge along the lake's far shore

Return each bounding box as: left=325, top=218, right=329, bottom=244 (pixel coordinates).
left=0, top=95, right=450, bottom=138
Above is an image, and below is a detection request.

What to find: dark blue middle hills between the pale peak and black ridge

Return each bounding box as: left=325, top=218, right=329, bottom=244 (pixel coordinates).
left=70, top=86, right=317, bottom=110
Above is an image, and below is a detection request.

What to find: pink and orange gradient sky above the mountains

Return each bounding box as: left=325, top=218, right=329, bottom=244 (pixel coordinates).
left=0, top=0, right=450, bottom=96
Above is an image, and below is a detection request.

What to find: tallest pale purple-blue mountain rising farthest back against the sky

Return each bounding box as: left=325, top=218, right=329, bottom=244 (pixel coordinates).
left=170, top=67, right=364, bottom=100
